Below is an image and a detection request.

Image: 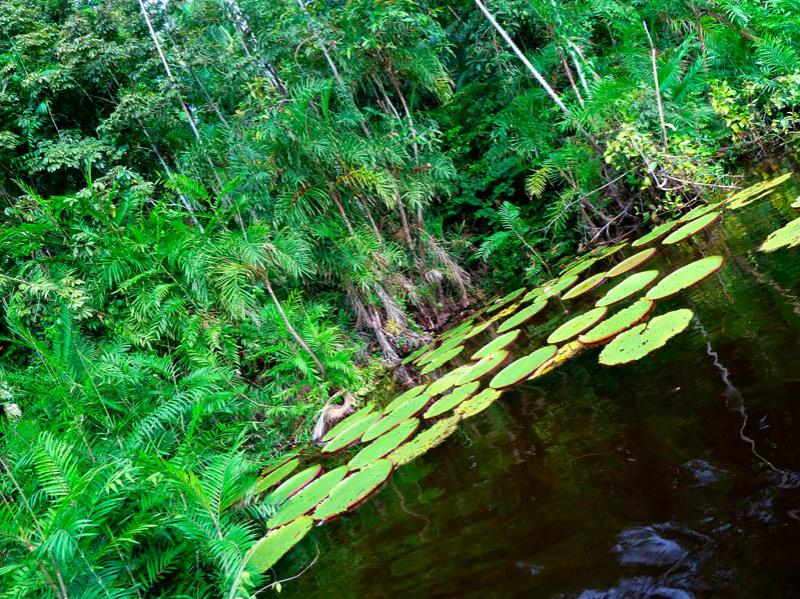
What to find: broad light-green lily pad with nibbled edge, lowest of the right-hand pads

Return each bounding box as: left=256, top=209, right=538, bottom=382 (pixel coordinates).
left=600, top=308, right=693, bottom=366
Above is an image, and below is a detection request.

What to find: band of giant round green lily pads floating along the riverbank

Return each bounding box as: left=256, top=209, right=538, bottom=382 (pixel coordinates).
left=238, top=175, right=800, bottom=572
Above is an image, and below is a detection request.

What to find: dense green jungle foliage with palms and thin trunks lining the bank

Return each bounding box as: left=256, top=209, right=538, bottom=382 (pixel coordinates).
left=0, top=0, right=800, bottom=597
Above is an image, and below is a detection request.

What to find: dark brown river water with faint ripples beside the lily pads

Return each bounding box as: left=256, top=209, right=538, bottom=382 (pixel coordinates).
left=277, top=169, right=800, bottom=598
